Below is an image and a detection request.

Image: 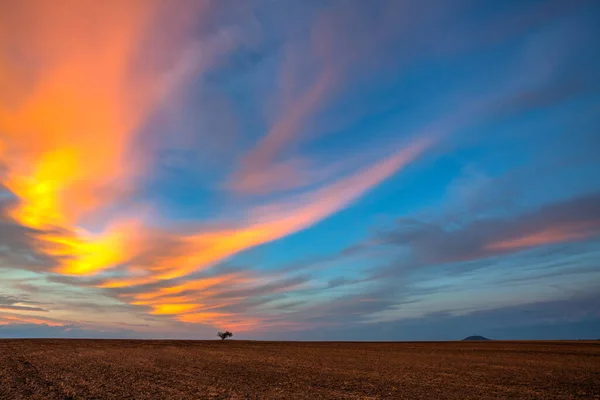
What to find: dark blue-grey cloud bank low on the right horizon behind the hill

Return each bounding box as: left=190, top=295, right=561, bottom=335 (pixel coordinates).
left=243, top=294, right=600, bottom=341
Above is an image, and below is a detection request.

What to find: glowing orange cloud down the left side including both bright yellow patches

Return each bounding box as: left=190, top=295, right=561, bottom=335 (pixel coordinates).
left=0, top=0, right=209, bottom=275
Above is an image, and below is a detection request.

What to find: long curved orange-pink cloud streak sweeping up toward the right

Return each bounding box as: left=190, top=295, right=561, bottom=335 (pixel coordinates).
left=103, top=139, right=431, bottom=287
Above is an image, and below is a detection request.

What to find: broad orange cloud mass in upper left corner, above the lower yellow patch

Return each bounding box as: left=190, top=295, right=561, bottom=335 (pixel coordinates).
left=0, top=0, right=163, bottom=228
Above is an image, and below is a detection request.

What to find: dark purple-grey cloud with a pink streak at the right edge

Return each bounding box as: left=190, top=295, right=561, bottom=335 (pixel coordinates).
left=379, top=193, right=600, bottom=263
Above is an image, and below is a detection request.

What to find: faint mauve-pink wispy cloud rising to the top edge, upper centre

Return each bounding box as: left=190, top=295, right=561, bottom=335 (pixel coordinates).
left=226, top=1, right=440, bottom=195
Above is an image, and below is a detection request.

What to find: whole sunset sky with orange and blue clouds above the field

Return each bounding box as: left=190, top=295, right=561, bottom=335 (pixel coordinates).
left=0, top=0, right=600, bottom=341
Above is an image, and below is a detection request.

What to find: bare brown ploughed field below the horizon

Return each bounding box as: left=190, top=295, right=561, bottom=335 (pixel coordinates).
left=0, top=339, right=600, bottom=400
